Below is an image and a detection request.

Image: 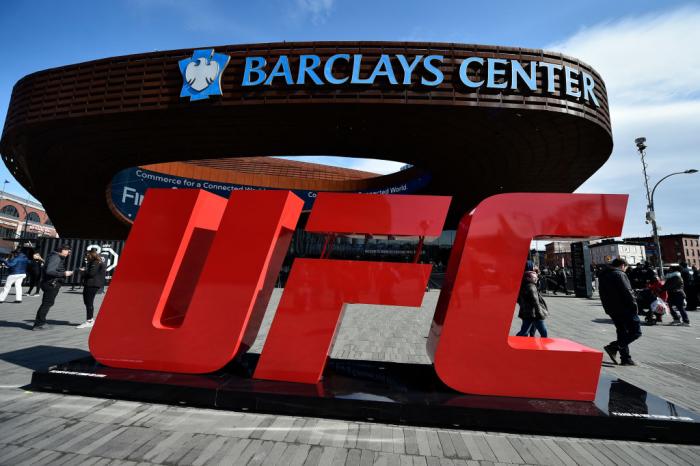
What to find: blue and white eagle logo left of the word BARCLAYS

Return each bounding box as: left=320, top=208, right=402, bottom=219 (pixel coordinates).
left=178, top=49, right=231, bottom=101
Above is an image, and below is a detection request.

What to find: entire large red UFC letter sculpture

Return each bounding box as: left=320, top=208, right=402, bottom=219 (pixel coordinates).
left=90, top=189, right=627, bottom=400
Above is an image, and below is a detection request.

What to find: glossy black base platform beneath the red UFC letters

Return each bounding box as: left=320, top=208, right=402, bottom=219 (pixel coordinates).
left=32, top=354, right=700, bottom=444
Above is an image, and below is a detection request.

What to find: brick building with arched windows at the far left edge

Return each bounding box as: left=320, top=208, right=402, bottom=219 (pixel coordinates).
left=0, top=193, right=58, bottom=256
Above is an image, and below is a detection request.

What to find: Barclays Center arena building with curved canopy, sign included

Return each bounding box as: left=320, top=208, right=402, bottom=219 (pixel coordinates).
left=0, top=42, right=612, bottom=251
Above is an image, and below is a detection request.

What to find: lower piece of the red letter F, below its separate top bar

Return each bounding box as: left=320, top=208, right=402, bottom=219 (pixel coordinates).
left=254, top=259, right=432, bottom=383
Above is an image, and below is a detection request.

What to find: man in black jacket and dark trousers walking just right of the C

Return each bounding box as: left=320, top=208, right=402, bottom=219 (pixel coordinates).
left=598, top=258, right=642, bottom=366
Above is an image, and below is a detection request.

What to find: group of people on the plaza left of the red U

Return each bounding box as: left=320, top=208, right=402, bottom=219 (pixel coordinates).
left=0, top=244, right=106, bottom=330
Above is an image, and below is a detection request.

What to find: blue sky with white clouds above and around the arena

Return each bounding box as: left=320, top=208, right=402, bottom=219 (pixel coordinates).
left=0, top=0, right=700, bottom=235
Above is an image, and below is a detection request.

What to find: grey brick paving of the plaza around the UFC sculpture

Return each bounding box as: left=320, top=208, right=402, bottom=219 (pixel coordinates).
left=0, top=290, right=700, bottom=465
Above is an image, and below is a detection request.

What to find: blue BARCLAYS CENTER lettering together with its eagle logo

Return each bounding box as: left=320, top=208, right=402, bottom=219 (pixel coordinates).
left=179, top=49, right=600, bottom=107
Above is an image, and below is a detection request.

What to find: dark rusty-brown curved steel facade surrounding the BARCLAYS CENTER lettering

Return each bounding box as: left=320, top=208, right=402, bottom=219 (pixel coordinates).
left=0, top=42, right=612, bottom=237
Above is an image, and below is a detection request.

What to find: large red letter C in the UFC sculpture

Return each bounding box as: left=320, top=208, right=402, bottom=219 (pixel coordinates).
left=428, top=193, right=627, bottom=400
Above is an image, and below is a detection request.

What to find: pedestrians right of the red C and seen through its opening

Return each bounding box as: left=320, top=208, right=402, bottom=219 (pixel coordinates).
left=516, top=258, right=700, bottom=366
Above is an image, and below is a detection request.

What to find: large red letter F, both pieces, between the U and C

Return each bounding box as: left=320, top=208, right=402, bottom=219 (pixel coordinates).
left=254, top=193, right=450, bottom=383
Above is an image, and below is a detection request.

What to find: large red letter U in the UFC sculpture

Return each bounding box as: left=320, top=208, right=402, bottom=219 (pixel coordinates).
left=90, top=189, right=303, bottom=373
